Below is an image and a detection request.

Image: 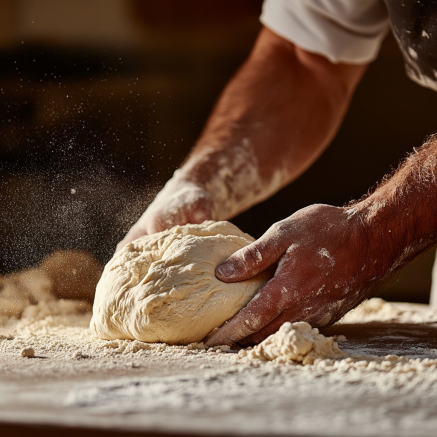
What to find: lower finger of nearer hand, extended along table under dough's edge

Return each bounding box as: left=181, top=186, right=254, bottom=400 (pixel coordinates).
left=206, top=278, right=286, bottom=347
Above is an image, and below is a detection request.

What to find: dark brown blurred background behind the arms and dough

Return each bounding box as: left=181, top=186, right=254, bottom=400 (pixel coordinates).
left=0, top=0, right=437, bottom=303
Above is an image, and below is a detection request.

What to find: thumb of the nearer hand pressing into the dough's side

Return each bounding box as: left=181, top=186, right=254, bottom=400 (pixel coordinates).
left=216, top=221, right=292, bottom=282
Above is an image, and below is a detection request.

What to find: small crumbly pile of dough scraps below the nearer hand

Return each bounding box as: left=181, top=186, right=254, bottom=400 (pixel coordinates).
left=238, top=322, right=343, bottom=365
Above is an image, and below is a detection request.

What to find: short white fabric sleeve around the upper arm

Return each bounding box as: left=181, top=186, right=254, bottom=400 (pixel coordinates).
left=260, top=0, right=390, bottom=64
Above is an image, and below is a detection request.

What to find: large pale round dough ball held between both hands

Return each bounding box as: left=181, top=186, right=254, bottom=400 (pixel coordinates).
left=90, top=221, right=269, bottom=344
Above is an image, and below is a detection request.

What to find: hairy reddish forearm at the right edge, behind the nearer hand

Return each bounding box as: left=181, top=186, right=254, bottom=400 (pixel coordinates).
left=347, top=135, right=437, bottom=282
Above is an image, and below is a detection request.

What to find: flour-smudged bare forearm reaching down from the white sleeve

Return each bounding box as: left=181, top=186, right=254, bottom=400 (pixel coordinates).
left=177, top=29, right=365, bottom=219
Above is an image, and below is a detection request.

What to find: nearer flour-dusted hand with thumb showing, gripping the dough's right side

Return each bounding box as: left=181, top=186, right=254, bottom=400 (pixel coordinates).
left=207, top=205, right=380, bottom=346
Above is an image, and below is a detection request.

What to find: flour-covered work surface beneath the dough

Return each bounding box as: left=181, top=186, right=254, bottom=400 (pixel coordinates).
left=0, top=300, right=437, bottom=436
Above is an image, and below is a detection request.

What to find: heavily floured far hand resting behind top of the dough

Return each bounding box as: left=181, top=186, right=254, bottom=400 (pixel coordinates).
left=117, top=173, right=216, bottom=251
